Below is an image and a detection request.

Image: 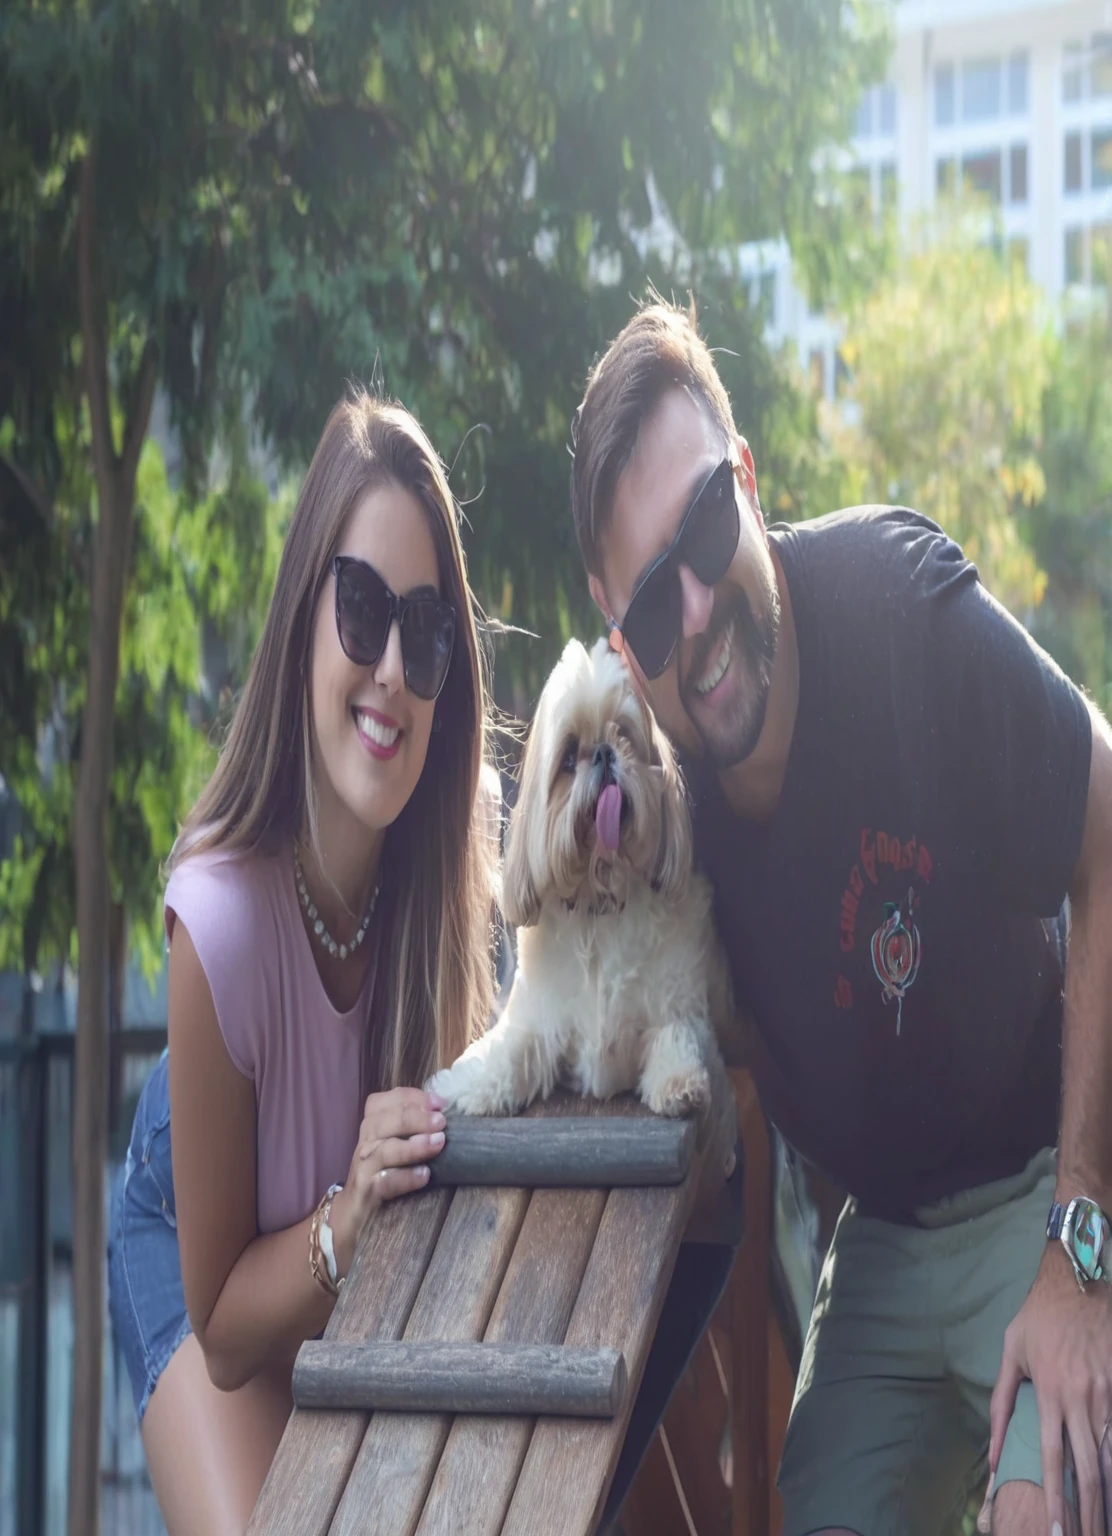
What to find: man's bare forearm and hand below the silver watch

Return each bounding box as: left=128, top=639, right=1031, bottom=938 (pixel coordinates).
left=989, top=710, right=1112, bottom=1536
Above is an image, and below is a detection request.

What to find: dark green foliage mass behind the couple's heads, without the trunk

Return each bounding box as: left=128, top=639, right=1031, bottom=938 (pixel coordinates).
left=0, top=0, right=886, bottom=962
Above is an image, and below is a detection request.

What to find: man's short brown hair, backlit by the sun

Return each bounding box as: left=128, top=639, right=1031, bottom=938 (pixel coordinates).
left=571, top=295, right=734, bottom=576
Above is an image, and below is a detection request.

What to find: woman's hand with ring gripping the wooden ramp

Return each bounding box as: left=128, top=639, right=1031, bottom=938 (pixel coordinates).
left=330, top=1087, right=444, bottom=1275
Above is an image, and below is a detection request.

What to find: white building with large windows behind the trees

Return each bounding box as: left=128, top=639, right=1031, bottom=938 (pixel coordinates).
left=758, top=0, right=1112, bottom=395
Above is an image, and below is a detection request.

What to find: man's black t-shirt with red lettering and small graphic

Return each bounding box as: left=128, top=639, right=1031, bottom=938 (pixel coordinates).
left=688, top=507, right=1090, bottom=1218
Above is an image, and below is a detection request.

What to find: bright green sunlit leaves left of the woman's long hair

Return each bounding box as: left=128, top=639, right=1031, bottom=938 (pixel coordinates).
left=0, top=414, right=289, bottom=972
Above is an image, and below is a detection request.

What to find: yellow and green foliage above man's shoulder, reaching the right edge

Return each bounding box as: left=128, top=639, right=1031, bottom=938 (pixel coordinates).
left=829, top=210, right=1112, bottom=710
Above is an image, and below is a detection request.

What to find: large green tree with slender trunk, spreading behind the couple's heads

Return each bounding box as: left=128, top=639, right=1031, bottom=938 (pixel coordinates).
left=0, top=0, right=880, bottom=1533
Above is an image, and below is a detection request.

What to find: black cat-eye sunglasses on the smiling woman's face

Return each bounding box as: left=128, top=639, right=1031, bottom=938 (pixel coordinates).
left=332, top=554, right=456, bottom=699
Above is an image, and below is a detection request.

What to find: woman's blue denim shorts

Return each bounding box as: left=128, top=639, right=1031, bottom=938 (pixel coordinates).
left=108, top=1051, right=190, bottom=1422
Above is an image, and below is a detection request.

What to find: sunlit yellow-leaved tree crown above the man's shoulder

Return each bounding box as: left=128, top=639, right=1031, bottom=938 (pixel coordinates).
left=836, top=220, right=1052, bottom=617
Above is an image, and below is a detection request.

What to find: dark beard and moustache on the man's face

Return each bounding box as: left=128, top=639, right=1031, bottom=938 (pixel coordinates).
left=680, top=582, right=780, bottom=770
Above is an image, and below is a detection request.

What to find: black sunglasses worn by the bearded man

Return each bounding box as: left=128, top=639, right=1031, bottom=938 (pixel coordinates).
left=614, top=458, right=742, bottom=679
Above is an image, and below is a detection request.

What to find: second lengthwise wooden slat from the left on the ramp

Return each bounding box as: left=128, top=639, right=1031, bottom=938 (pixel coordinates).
left=330, top=1189, right=528, bottom=1536
